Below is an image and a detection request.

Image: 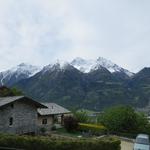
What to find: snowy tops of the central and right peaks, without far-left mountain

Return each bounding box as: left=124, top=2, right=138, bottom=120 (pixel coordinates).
left=42, top=57, right=133, bottom=77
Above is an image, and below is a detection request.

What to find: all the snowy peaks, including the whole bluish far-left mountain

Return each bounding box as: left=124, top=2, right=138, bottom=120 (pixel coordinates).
left=0, top=57, right=133, bottom=86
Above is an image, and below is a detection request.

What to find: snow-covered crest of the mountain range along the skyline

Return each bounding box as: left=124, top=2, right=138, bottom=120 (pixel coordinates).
left=0, top=57, right=134, bottom=79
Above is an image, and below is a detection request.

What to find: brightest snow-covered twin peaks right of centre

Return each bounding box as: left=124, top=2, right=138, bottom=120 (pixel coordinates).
left=71, top=57, right=133, bottom=76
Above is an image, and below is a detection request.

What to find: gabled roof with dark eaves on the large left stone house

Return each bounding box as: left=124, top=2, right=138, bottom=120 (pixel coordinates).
left=0, top=96, right=47, bottom=108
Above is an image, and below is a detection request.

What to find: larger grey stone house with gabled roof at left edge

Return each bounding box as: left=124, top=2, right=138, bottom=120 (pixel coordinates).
left=0, top=96, right=47, bottom=134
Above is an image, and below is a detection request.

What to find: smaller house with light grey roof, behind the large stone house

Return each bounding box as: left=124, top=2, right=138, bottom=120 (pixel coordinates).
left=38, top=103, right=71, bottom=130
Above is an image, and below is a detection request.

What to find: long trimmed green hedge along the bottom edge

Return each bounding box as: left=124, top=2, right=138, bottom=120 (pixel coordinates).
left=0, top=135, right=120, bottom=150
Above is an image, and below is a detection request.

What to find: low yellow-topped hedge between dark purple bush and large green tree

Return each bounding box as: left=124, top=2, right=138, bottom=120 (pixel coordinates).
left=78, top=123, right=107, bottom=135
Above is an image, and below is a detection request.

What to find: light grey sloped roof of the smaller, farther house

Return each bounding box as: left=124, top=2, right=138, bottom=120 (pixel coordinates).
left=38, top=103, right=70, bottom=116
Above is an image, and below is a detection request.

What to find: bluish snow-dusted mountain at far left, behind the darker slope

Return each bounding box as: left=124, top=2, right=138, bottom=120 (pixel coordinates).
left=0, top=63, right=41, bottom=85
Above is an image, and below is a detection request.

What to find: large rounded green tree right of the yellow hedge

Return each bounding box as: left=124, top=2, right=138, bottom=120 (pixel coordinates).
left=99, top=106, right=143, bottom=133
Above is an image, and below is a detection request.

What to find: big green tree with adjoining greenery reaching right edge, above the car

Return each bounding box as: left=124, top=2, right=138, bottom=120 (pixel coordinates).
left=98, top=106, right=150, bottom=135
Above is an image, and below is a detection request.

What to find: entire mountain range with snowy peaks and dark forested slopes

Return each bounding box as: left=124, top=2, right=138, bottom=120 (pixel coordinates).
left=0, top=57, right=150, bottom=111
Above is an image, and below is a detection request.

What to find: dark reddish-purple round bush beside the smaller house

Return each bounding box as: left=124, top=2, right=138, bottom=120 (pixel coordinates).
left=64, top=116, right=78, bottom=132
